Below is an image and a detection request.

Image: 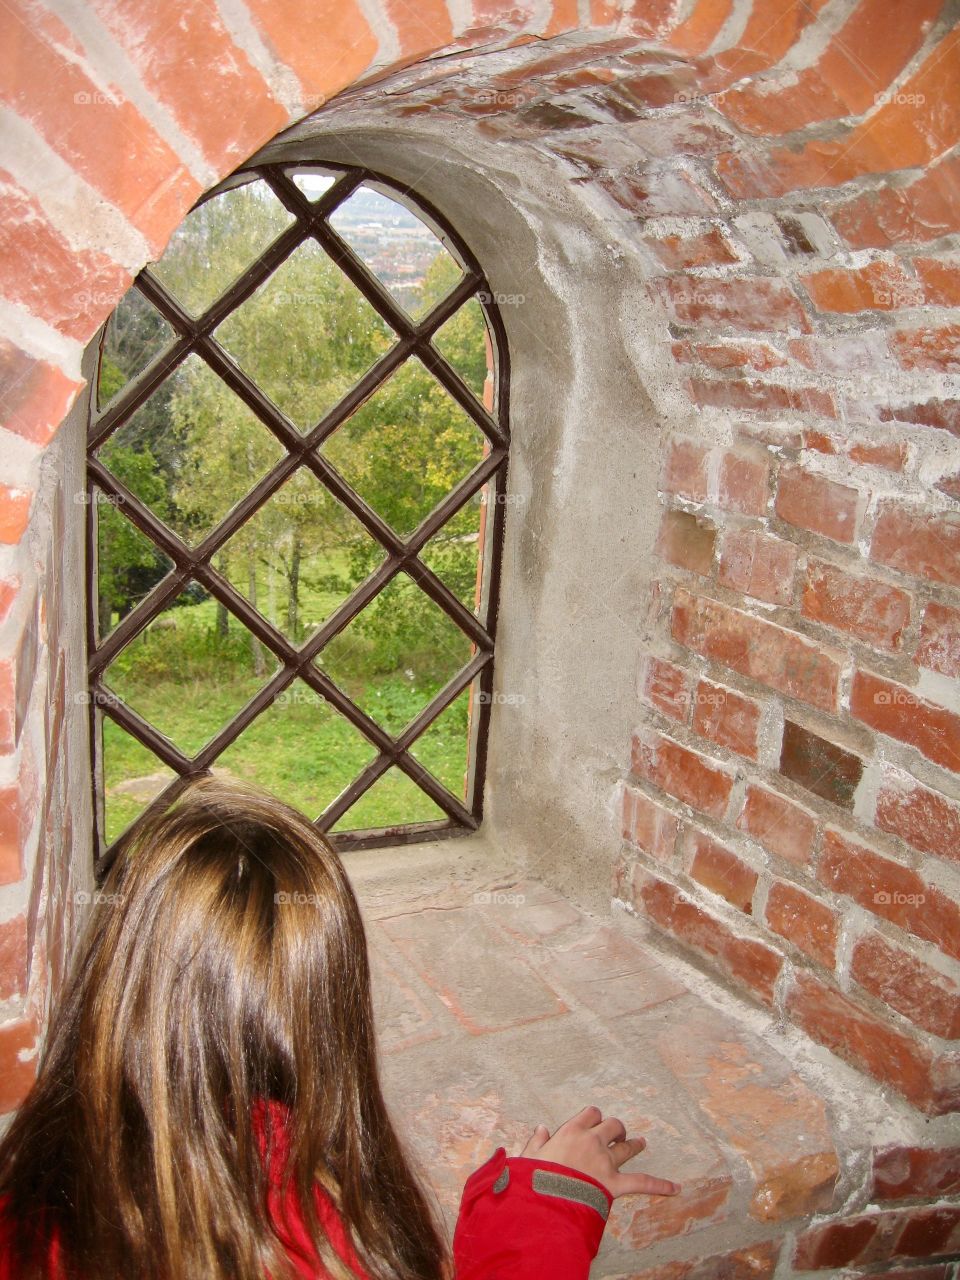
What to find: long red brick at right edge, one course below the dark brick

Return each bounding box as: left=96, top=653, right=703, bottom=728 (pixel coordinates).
left=817, top=829, right=960, bottom=960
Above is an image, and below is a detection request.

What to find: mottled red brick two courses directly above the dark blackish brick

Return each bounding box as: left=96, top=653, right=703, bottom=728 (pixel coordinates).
left=801, top=559, right=911, bottom=652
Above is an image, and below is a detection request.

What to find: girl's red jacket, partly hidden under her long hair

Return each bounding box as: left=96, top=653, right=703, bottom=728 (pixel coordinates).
left=0, top=1100, right=613, bottom=1280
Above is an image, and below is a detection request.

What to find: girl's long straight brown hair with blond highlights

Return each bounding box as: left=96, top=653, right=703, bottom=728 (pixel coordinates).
left=0, top=778, right=447, bottom=1280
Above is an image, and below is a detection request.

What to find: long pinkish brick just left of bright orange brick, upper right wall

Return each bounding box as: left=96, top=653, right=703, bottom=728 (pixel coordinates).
left=658, top=278, right=810, bottom=333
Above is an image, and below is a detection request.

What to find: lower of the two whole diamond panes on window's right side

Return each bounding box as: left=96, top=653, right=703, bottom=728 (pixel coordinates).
left=317, top=573, right=472, bottom=737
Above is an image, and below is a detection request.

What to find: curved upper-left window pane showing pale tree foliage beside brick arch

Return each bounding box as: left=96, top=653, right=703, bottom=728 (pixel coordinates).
left=150, top=180, right=293, bottom=316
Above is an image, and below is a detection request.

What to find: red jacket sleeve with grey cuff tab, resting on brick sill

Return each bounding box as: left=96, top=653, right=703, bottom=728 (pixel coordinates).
left=453, top=1147, right=613, bottom=1280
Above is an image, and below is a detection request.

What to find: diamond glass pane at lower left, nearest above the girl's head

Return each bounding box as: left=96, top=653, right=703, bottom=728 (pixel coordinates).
left=105, top=582, right=276, bottom=756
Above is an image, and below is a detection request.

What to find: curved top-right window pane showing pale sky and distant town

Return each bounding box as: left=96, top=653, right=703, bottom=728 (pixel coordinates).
left=330, top=187, right=463, bottom=320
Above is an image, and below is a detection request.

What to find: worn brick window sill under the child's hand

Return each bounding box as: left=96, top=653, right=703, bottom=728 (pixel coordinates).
left=353, top=846, right=960, bottom=1280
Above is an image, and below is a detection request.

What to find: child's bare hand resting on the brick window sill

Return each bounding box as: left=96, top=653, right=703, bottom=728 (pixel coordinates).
left=520, top=1107, right=680, bottom=1199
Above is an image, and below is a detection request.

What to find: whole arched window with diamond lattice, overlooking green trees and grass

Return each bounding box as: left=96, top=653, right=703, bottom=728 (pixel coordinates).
left=87, top=165, right=508, bottom=868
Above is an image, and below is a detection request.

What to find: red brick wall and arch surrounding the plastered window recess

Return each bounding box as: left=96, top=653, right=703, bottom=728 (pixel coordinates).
left=0, top=0, right=960, bottom=1167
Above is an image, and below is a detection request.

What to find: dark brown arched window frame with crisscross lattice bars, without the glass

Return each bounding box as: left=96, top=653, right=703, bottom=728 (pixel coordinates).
left=86, top=160, right=509, bottom=878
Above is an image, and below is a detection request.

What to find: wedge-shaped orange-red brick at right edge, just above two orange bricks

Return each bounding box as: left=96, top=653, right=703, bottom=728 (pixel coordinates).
left=831, top=156, right=960, bottom=248
